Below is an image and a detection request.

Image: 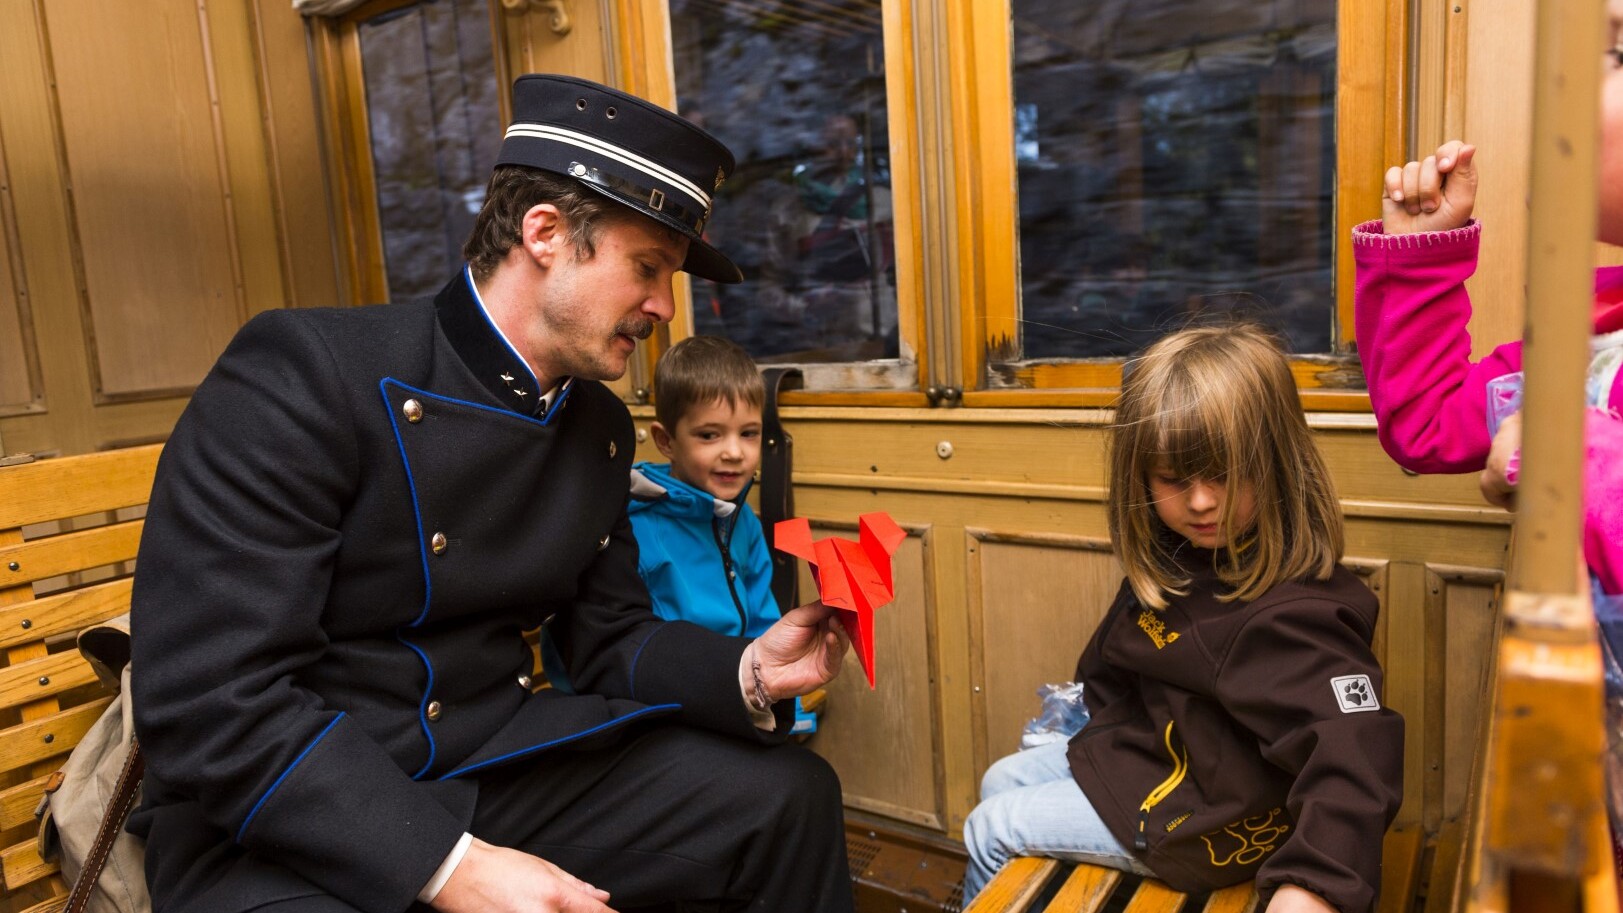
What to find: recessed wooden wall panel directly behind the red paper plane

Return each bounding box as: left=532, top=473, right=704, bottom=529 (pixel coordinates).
left=800, top=524, right=945, bottom=830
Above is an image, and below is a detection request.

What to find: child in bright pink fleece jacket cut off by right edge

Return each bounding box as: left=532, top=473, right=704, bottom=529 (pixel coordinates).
left=1352, top=130, right=1623, bottom=595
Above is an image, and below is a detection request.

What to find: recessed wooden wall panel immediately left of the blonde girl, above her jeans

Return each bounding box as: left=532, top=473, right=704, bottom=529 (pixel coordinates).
left=967, top=530, right=1121, bottom=778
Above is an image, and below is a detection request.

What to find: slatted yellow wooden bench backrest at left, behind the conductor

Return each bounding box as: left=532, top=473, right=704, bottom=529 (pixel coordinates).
left=0, top=444, right=161, bottom=910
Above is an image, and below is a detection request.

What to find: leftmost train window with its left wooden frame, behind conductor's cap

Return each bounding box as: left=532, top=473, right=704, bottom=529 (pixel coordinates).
left=313, top=0, right=505, bottom=303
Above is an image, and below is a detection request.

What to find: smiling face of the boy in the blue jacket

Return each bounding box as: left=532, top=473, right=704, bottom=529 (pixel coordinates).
left=652, top=399, right=761, bottom=501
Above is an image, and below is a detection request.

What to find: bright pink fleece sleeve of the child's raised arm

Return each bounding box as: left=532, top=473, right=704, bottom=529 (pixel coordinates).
left=1352, top=221, right=1521, bottom=472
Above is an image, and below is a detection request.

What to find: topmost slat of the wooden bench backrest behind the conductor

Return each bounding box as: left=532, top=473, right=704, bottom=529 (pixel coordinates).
left=0, top=444, right=162, bottom=529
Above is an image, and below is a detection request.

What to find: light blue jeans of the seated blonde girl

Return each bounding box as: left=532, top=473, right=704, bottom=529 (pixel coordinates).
left=964, top=741, right=1152, bottom=905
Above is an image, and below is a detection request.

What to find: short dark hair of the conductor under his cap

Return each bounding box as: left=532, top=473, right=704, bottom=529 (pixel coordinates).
left=463, top=165, right=623, bottom=281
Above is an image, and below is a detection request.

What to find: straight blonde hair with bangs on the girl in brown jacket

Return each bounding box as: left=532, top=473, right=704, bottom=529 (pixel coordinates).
left=1109, top=323, right=1344, bottom=608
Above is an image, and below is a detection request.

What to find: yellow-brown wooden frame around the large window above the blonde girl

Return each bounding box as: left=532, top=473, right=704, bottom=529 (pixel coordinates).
left=949, top=0, right=1409, bottom=412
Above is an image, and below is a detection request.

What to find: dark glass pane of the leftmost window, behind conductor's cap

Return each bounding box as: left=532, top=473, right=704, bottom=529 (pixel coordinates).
left=360, top=0, right=502, bottom=302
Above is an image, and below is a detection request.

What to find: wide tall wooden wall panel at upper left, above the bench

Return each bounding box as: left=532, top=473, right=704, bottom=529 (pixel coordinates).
left=45, top=0, right=243, bottom=397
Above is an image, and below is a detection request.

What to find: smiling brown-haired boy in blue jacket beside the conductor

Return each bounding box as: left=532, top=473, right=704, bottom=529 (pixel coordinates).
left=628, top=336, right=816, bottom=733
